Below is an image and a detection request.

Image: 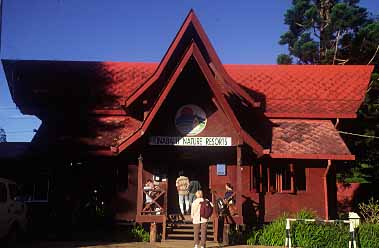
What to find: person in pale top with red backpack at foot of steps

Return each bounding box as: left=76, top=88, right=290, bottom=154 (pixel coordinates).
left=191, top=190, right=213, bottom=248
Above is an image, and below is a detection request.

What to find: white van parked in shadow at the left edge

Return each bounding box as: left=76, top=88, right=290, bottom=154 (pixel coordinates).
left=0, top=178, right=27, bottom=242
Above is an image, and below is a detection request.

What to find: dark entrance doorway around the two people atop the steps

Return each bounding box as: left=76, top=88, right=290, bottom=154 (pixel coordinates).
left=167, top=160, right=211, bottom=214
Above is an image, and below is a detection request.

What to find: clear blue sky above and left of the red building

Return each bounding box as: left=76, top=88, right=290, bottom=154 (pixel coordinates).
left=0, top=0, right=379, bottom=141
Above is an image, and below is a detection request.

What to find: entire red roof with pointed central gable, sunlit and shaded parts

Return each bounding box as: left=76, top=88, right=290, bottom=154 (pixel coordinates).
left=3, top=11, right=373, bottom=159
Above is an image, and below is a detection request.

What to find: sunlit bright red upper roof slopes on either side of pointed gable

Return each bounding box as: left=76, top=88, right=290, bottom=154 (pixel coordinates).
left=98, top=62, right=373, bottom=118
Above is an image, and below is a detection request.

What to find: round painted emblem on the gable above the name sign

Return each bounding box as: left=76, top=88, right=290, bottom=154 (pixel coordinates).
left=175, top=104, right=207, bottom=136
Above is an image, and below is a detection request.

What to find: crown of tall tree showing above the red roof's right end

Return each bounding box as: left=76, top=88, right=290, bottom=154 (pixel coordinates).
left=278, top=0, right=379, bottom=64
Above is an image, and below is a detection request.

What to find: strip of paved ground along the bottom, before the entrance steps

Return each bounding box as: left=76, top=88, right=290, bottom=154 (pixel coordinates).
left=20, top=241, right=274, bottom=248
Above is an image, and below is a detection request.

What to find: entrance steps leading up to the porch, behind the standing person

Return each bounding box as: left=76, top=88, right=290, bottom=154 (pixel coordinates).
left=166, top=215, right=214, bottom=241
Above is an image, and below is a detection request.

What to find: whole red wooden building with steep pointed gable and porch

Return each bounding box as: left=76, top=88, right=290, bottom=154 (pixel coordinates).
left=3, top=11, right=373, bottom=237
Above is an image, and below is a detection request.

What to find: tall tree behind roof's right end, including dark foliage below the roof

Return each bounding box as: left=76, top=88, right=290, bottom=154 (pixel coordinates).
left=277, top=0, right=379, bottom=182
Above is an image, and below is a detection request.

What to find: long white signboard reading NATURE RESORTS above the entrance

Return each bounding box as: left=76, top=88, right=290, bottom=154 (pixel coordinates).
left=149, top=136, right=232, bottom=146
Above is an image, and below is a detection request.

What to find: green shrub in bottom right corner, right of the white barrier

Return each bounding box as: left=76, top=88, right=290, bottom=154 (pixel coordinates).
left=358, top=223, right=379, bottom=248
